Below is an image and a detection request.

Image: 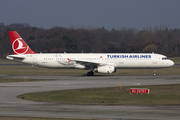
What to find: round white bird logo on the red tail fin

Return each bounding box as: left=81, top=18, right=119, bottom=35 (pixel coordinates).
left=12, top=38, right=28, bottom=54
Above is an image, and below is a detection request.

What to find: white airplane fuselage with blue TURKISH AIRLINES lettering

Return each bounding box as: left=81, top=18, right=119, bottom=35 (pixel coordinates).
left=7, top=53, right=174, bottom=69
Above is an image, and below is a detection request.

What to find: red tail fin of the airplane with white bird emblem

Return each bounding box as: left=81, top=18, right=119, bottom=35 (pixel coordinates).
left=9, top=31, right=36, bottom=55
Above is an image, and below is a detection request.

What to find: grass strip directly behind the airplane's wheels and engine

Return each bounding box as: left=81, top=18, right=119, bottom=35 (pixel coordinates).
left=0, top=65, right=180, bottom=75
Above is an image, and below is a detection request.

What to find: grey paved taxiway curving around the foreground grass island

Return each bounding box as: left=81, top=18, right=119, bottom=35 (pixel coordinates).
left=0, top=75, right=180, bottom=120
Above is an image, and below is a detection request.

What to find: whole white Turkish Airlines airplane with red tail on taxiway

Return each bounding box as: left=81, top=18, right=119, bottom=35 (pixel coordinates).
left=6, top=31, right=174, bottom=76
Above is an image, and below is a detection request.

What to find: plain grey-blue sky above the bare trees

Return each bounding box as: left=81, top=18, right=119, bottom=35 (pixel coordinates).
left=0, top=0, right=180, bottom=30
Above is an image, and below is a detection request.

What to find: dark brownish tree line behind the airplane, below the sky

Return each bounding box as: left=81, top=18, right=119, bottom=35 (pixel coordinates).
left=0, top=23, right=180, bottom=58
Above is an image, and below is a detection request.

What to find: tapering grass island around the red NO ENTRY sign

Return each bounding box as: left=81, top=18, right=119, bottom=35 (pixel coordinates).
left=18, top=84, right=180, bottom=105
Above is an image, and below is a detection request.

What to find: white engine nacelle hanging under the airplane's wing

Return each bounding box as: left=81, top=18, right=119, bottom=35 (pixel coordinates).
left=95, top=65, right=116, bottom=73
